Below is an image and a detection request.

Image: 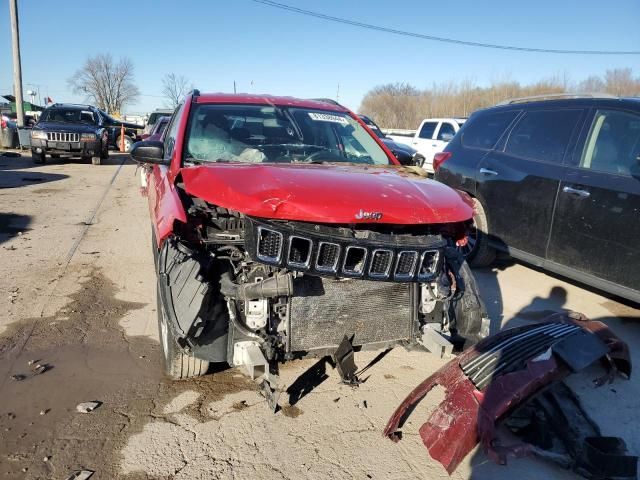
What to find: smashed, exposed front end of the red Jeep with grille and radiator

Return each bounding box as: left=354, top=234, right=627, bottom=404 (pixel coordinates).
left=157, top=187, right=489, bottom=398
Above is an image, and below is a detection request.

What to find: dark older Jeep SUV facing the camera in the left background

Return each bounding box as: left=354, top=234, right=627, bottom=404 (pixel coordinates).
left=31, top=103, right=109, bottom=165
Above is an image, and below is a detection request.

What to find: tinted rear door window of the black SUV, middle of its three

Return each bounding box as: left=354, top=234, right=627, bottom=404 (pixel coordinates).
left=505, top=110, right=581, bottom=163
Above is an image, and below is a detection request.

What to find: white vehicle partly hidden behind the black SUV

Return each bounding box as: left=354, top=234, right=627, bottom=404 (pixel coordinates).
left=391, top=118, right=466, bottom=173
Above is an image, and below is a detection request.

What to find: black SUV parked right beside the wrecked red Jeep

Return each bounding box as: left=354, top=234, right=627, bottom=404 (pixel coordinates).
left=434, top=97, right=640, bottom=302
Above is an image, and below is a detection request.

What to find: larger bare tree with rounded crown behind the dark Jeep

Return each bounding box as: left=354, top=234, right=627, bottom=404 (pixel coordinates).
left=68, top=53, right=140, bottom=113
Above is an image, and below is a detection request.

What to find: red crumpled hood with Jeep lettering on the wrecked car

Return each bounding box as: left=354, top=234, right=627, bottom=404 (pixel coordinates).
left=180, top=163, right=473, bottom=224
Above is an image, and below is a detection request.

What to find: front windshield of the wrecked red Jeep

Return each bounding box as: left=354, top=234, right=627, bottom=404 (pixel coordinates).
left=185, top=104, right=390, bottom=165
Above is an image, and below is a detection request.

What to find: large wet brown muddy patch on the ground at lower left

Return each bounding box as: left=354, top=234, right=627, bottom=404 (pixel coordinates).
left=0, top=269, right=253, bottom=479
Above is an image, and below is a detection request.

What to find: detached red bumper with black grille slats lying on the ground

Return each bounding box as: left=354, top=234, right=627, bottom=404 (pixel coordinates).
left=384, top=312, right=635, bottom=478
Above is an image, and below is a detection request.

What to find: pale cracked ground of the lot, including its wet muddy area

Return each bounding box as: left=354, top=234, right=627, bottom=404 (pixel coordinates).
left=0, top=154, right=640, bottom=480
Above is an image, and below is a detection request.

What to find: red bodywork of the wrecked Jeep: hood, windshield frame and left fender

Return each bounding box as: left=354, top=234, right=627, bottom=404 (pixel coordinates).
left=148, top=93, right=473, bottom=245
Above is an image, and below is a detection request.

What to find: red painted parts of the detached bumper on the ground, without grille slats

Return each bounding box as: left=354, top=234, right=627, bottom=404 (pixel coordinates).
left=384, top=313, right=631, bottom=474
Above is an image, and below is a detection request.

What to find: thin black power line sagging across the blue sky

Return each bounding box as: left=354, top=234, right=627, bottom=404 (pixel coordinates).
left=252, top=0, right=640, bottom=55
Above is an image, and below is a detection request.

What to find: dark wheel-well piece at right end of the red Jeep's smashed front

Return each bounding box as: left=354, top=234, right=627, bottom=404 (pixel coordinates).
left=449, top=259, right=491, bottom=349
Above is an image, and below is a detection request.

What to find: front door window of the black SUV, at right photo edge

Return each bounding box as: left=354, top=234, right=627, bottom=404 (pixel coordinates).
left=580, top=110, right=640, bottom=175
